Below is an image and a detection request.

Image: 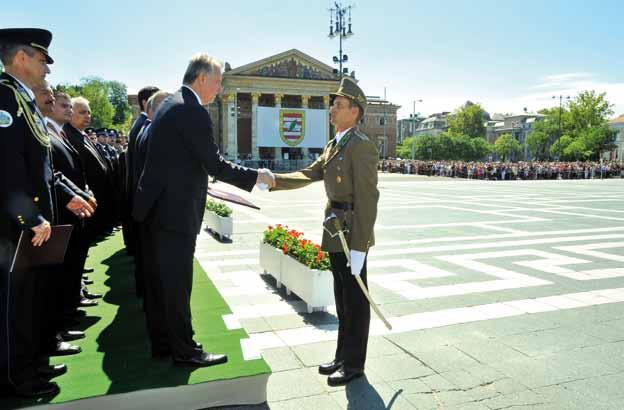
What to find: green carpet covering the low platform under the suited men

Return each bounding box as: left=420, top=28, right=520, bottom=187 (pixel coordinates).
left=3, top=232, right=271, bottom=408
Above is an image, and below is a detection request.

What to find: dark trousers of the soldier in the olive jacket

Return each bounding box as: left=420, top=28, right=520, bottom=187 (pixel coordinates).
left=329, top=252, right=370, bottom=371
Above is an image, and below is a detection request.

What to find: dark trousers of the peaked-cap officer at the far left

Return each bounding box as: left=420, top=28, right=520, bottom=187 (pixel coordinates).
left=0, top=237, right=37, bottom=386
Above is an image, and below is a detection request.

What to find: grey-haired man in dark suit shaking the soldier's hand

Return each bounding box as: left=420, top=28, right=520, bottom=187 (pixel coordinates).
left=133, top=54, right=266, bottom=367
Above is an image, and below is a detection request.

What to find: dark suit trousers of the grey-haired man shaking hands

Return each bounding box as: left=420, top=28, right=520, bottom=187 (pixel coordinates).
left=141, top=218, right=197, bottom=359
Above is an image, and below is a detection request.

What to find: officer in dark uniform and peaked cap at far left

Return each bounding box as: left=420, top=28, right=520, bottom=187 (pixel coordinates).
left=0, top=29, right=94, bottom=396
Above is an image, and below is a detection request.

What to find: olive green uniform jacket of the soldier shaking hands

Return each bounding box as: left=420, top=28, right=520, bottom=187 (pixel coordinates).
left=273, top=127, right=379, bottom=252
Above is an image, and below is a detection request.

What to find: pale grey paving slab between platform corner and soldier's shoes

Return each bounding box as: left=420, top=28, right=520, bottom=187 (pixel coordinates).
left=267, top=368, right=325, bottom=403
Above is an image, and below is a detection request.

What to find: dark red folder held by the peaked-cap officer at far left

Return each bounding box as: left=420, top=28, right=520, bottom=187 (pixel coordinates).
left=11, top=225, right=74, bottom=272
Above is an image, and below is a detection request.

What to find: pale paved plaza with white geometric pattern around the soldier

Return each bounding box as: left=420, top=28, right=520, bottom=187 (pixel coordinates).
left=194, top=174, right=624, bottom=410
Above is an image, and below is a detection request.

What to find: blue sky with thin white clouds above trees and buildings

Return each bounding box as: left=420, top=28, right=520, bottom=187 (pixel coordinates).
left=0, top=0, right=624, bottom=117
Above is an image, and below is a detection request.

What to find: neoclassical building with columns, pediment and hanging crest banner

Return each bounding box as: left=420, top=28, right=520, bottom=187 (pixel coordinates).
left=129, top=49, right=398, bottom=161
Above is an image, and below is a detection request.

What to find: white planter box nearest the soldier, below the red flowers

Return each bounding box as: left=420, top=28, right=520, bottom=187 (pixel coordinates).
left=281, top=255, right=335, bottom=313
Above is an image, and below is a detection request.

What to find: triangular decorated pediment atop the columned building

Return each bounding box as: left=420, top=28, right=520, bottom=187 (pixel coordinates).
left=225, top=48, right=338, bottom=81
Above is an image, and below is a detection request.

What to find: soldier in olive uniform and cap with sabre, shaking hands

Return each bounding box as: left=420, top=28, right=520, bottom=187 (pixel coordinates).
left=273, top=77, right=379, bottom=386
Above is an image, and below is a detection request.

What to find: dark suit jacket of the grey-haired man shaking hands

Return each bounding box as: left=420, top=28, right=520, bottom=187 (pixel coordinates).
left=133, top=87, right=257, bottom=235
